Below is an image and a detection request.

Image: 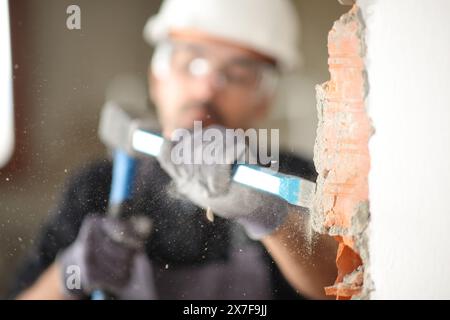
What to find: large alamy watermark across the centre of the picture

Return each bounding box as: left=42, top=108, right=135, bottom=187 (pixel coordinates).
left=170, top=121, right=280, bottom=171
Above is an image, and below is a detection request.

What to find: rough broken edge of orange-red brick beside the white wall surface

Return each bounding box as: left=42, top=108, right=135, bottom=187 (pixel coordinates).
left=313, top=6, right=372, bottom=299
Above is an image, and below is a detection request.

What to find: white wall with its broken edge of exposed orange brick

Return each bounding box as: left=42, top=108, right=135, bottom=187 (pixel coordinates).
left=313, top=0, right=450, bottom=299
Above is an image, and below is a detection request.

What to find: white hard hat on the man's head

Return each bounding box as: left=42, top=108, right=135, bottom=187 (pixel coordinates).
left=144, top=0, right=301, bottom=71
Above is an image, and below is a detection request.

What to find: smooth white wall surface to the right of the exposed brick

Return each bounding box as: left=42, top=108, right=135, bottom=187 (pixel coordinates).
left=358, top=0, right=450, bottom=299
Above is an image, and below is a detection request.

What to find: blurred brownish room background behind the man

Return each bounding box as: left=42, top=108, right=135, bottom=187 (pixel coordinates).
left=0, top=0, right=348, bottom=297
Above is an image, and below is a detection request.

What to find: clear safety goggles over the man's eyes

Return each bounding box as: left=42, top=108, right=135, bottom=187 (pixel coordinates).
left=151, top=41, right=279, bottom=98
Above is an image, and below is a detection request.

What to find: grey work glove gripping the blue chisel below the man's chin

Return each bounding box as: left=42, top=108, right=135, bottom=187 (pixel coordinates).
left=158, top=126, right=288, bottom=240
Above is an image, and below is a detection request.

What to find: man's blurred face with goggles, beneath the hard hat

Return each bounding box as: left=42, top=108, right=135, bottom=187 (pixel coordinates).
left=150, top=33, right=275, bottom=137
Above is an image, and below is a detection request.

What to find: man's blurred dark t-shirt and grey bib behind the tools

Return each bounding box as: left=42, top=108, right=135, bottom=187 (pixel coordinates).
left=9, top=154, right=315, bottom=299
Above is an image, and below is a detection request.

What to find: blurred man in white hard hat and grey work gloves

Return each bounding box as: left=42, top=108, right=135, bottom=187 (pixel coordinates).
left=12, top=0, right=336, bottom=299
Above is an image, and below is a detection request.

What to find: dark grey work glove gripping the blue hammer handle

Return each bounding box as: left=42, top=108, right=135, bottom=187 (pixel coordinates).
left=57, top=215, right=155, bottom=299
